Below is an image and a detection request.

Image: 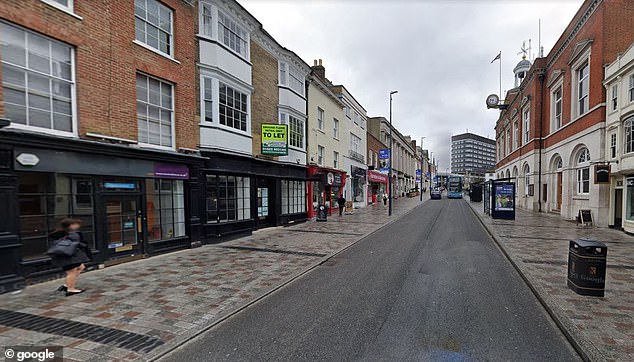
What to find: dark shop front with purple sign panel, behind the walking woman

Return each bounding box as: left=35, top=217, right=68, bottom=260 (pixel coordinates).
left=0, top=135, right=200, bottom=292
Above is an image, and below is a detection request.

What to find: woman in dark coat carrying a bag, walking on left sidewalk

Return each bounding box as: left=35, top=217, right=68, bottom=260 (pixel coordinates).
left=49, top=219, right=92, bottom=297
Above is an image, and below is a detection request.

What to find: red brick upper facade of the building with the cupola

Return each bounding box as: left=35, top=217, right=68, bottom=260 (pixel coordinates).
left=495, top=0, right=634, bottom=169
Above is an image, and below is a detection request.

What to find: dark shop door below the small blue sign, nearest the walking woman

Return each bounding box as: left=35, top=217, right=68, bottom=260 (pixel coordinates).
left=104, top=195, right=143, bottom=259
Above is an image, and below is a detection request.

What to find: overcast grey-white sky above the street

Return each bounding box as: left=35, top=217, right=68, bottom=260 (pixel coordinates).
left=238, top=0, right=583, bottom=171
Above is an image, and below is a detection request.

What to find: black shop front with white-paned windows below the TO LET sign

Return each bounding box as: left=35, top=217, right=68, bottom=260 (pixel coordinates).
left=200, top=152, right=307, bottom=243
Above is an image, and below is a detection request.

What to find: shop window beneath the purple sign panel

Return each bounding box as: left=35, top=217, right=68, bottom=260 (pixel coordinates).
left=145, top=179, right=185, bottom=241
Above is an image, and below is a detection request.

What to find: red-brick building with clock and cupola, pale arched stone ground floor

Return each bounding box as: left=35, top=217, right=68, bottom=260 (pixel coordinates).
left=495, top=0, right=634, bottom=226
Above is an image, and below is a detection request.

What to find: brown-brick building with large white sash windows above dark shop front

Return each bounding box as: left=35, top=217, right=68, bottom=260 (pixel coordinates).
left=0, top=0, right=200, bottom=292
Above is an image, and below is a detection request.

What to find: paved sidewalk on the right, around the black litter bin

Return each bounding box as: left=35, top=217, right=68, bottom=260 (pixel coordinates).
left=470, top=203, right=634, bottom=361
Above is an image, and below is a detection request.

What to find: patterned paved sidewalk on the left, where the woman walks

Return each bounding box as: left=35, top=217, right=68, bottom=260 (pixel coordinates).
left=0, top=197, right=427, bottom=361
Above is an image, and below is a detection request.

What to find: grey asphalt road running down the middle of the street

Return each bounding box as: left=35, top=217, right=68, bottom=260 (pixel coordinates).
left=165, top=199, right=580, bottom=362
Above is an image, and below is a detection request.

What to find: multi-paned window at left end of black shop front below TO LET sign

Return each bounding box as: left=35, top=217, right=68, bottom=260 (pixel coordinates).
left=207, top=175, right=251, bottom=223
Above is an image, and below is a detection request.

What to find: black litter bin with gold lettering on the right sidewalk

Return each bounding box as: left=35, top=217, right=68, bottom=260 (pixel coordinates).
left=568, top=238, right=608, bottom=297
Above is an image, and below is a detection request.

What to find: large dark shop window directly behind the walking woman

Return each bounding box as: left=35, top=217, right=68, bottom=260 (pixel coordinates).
left=18, top=172, right=95, bottom=260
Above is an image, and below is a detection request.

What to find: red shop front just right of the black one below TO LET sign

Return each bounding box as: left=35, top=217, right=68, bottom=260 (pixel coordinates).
left=307, top=165, right=346, bottom=218
